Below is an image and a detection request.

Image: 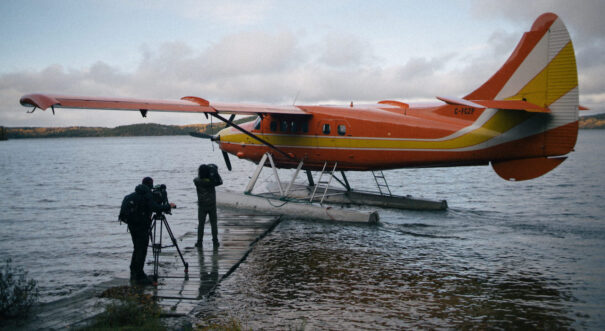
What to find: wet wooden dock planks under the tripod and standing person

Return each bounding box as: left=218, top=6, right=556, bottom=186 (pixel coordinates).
left=147, top=212, right=280, bottom=316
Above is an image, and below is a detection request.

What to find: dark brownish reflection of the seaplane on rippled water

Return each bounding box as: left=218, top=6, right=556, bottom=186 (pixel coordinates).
left=198, top=222, right=574, bottom=329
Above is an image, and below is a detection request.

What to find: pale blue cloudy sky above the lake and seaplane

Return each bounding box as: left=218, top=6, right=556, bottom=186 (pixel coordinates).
left=0, top=0, right=605, bottom=127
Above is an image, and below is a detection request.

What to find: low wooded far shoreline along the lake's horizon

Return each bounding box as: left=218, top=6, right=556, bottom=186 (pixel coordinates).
left=0, top=114, right=605, bottom=140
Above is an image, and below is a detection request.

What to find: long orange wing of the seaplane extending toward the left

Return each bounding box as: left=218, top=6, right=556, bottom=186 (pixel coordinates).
left=20, top=94, right=311, bottom=116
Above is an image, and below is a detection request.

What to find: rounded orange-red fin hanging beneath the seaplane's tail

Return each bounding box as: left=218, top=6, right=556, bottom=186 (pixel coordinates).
left=492, top=157, right=567, bottom=181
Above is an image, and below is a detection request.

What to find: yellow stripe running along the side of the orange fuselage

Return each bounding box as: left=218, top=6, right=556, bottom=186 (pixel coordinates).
left=221, top=110, right=533, bottom=150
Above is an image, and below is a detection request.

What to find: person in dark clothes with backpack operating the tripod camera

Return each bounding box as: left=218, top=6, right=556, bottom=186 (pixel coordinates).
left=120, top=177, right=176, bottom=285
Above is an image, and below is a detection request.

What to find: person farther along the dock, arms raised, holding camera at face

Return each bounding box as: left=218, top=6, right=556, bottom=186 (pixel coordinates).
left=193, top=164, right=223, bottom=248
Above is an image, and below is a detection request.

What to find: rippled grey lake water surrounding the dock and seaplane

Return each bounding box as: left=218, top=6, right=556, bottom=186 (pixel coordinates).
left=0, top=131, right=605, bottom=329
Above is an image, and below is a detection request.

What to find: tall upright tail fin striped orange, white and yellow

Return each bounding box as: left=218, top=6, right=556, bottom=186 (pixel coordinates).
left=464, top=13, right=580, bottom=182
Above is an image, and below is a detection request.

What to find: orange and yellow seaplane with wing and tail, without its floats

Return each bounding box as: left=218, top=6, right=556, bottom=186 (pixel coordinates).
left=20, top=13, right=584, bottom=220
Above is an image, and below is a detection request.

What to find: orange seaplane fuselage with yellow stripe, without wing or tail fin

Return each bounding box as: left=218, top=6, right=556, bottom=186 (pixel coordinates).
left=218, top=101, right=577, bottom=176
